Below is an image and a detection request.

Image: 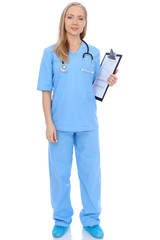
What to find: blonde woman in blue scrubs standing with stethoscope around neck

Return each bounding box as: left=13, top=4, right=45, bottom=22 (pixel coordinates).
left=37, top=2, right=117, bottom=238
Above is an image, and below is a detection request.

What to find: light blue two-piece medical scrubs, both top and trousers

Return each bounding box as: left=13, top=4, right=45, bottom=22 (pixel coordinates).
left=37, top=42, right=101, bottom=226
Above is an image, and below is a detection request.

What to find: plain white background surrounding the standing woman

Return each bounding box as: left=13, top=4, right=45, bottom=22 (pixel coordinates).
left=0, top=0, right=160, bottom=240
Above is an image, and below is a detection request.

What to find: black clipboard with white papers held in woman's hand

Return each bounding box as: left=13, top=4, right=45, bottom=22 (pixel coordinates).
left=93, top=49, right=122, bottom=102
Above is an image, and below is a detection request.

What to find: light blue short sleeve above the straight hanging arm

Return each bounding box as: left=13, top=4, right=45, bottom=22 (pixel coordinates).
left=37, top=48, right=53, bottom=91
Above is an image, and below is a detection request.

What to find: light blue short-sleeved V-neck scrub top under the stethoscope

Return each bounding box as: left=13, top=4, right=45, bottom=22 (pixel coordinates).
left=37, top=42, right=100, bottom=132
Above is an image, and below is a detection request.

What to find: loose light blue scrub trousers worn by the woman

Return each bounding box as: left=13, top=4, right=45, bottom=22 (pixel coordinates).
left=48, top=128, right=101, bottom=227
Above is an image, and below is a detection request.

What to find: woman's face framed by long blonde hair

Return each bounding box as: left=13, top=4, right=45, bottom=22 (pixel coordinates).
left=65, top=6, right=86, bottom=36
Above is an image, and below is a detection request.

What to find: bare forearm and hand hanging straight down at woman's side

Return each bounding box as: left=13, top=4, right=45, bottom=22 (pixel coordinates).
left=42, top=91, right=57, bottom=142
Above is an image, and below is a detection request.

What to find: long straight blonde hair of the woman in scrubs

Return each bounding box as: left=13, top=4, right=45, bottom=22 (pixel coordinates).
left=53, top=2, right=87, bottom=62
